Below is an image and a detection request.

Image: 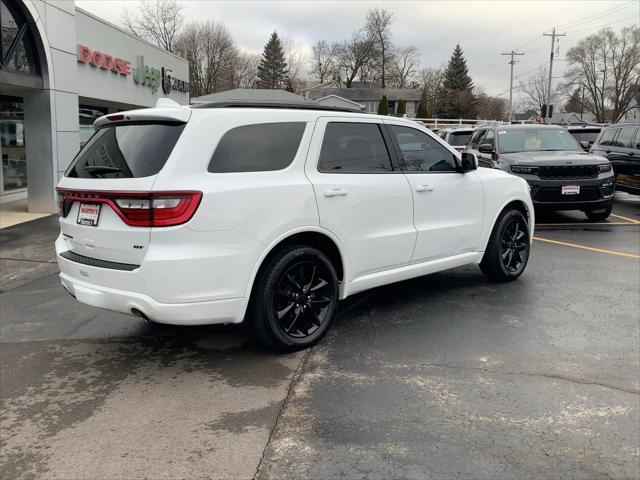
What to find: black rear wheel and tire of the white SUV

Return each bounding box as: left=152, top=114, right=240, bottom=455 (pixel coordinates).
left=249, top=245, right=338, bottom=352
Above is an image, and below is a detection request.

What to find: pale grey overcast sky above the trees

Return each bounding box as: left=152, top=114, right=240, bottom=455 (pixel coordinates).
left=76, top=0, right=640, bottom=97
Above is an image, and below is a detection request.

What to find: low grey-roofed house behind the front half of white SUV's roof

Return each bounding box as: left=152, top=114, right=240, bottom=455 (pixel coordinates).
left=305, top=85, right=422, bottom=117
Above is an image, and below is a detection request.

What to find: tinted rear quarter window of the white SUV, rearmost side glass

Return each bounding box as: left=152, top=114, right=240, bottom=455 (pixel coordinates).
left=208, top=122, right=306, bottom=173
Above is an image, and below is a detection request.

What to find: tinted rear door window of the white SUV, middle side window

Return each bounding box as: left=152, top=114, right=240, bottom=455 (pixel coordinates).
left=318, top=122, right=393, bottom=173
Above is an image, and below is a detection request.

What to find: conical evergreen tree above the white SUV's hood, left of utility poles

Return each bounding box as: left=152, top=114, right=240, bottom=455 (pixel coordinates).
left=443, top=45, right=477, bottom=118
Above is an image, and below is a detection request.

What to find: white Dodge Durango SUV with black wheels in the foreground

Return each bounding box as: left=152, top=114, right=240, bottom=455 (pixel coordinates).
left=56, top=102, right=534, bottom=350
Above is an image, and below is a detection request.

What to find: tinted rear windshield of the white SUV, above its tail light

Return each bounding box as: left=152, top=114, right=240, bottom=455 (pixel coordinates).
left=65, top=123, right=185, bottom=178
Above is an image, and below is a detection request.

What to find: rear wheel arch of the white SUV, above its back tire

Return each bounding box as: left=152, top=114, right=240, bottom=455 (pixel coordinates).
left=245, top=226, right=348, bottom=298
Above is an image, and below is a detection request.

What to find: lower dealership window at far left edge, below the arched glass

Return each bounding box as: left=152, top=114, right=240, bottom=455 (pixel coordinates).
left=0, top=95, right=27, bottom=193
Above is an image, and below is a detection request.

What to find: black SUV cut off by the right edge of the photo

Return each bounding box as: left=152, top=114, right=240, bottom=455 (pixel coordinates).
left=590, top=123, right=640, bottom=195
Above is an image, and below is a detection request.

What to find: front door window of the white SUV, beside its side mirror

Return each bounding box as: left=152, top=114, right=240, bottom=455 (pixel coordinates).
left=389, top=125, right=456, bottom=172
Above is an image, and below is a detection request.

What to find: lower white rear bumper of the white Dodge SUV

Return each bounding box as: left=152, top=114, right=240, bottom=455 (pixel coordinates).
left=58, top=272, right=249, bottom=325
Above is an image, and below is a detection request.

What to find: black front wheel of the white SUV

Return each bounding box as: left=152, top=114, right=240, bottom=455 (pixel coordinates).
left=480, top=209, right=531, bottom=282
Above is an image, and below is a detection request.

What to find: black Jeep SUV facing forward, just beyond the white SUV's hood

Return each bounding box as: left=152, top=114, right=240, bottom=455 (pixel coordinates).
left=465, top=125, right=614, bottom=220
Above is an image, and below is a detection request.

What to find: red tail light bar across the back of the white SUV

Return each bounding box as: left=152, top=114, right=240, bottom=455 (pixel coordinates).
left=57, top=189, right=202, bottom=227
